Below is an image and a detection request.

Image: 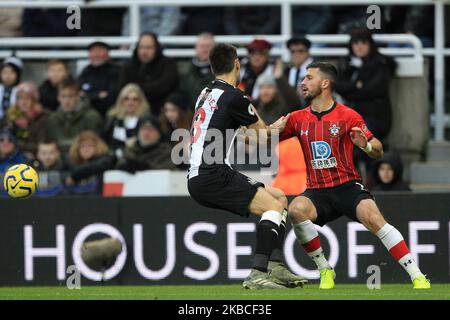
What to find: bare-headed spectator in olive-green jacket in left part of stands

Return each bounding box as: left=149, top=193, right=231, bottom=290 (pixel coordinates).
left=48, top=79, right=103, bottom=153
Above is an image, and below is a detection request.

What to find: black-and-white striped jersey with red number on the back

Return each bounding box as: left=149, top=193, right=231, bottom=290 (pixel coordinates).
left=188, top=80, right=258, bottom=178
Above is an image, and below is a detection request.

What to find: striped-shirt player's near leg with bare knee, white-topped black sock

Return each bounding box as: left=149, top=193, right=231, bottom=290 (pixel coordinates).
left=243, top=187, right=286, bottom=289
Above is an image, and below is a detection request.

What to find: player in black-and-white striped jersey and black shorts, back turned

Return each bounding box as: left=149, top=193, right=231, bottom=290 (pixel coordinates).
left=188, top=44, right=306, bottom=289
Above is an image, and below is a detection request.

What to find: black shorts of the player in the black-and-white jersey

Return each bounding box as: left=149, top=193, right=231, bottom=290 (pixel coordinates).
left=188, top=165, right=264, bottom=217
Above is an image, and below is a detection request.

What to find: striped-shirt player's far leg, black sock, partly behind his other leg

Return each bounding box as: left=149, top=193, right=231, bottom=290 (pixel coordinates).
left=265, top=186, right=308, bottom=287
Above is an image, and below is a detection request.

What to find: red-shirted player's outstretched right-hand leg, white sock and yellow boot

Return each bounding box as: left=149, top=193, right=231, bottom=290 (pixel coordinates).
left=356, top=199, right=431, bottom=289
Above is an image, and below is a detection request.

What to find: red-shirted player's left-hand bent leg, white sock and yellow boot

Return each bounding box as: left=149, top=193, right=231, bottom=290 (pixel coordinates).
left=288, top=196, right=336, bottom=289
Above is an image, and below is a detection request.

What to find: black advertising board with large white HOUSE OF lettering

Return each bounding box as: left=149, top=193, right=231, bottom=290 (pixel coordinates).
left=0, top=193, right=450, bottom=287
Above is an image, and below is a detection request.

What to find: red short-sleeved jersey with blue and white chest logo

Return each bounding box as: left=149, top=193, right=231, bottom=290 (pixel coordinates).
left=280, top=102, right=373, bottom=189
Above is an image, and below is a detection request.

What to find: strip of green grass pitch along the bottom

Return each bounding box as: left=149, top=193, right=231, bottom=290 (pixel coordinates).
left=0, top=284, right=450, bottom=300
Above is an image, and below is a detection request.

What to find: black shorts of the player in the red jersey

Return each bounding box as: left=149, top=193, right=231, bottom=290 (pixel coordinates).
left=301, top=181, right=374, bottom=226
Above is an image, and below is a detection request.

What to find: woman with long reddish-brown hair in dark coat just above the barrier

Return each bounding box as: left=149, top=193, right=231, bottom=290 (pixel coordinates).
left=66, top=130, right=116, bottom=194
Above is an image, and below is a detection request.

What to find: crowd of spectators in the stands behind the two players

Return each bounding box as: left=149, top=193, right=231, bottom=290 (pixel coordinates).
left=0, top=3, right=432, bottom=196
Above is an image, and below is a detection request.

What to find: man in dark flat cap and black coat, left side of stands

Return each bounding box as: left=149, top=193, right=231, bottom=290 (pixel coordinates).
left=78, top=41, right=119, bottom=117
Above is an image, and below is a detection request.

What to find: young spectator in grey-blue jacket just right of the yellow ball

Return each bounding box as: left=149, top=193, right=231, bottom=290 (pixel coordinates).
left=31, top=140, right=67, bottom=197
